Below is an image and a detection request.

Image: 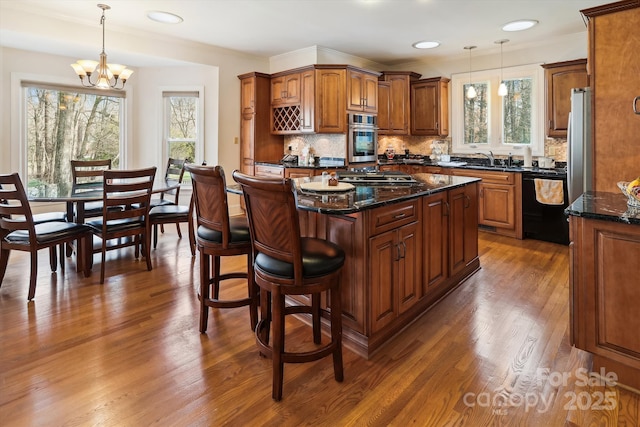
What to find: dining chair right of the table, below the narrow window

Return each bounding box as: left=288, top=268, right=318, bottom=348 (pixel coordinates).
left=149, top=158, right=196, bottom=256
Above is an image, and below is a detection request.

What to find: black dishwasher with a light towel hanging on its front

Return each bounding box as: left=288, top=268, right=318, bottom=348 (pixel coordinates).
left=522, top=168, right=569, bottom=245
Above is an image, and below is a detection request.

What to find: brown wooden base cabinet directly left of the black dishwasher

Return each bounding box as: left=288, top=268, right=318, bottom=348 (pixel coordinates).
left=450, top=168, right=523, bottom=239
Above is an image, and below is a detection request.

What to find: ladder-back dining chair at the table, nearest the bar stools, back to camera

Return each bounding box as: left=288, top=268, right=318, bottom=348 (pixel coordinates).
left=87, top=166, right=156, bottom=284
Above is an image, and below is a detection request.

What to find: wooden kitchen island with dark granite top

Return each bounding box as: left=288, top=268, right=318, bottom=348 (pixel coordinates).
left=234, top=174, right=480, bottom=358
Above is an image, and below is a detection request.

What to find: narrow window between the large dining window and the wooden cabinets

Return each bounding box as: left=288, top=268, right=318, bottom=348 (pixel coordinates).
left=162, top=91, right=202, bottom=183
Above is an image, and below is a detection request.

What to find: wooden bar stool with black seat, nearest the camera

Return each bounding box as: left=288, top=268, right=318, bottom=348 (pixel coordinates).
left=233, top=171, right=345, bottom=401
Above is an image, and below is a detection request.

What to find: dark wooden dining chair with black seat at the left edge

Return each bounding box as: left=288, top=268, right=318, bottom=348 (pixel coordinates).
left=0, top=173, right=92, bottom=300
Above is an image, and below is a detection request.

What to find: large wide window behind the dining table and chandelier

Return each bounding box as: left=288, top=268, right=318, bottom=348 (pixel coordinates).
left=22, top=82, right=125, bottom=196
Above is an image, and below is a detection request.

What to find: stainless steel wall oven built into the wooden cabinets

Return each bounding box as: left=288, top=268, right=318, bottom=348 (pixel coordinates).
left=347, top=113, right=378, bottom=163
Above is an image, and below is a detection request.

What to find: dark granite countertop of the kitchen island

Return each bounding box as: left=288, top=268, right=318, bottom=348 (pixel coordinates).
left=227, top=173, right=480, bottom=215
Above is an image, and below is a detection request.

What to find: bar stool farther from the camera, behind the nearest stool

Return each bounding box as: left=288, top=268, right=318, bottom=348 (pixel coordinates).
left=185, top=164, right=258, bottom=333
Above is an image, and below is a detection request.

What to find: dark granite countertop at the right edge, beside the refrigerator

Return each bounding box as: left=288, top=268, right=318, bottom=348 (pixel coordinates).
left=564, top=191, right=640, bottom=225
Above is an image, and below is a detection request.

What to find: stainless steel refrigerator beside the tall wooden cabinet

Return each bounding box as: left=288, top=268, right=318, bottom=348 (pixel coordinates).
left=567, top=87, right=593, bottom=203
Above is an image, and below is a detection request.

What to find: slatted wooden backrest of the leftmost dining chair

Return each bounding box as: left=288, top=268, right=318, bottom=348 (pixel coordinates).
left=0, top=173, right=36, bottom=245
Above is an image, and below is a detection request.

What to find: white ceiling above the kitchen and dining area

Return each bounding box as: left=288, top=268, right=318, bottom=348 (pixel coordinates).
left=0, top=0, right=608, bottom=66
